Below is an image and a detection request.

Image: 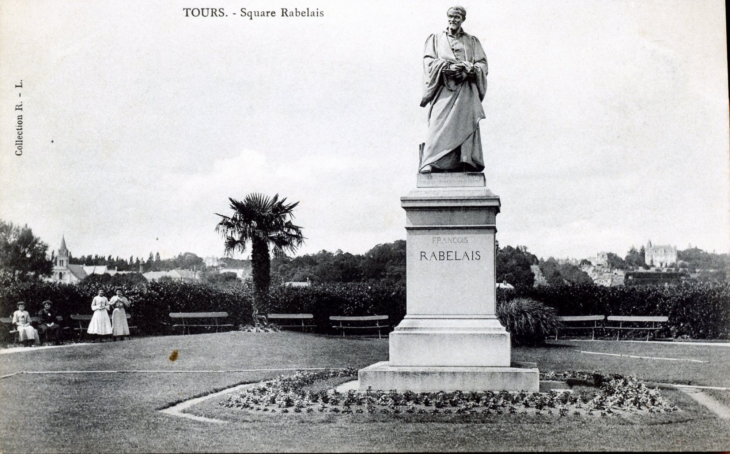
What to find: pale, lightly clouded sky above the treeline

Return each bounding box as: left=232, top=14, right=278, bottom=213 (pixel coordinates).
left=0, top=0, right=730, bottom=258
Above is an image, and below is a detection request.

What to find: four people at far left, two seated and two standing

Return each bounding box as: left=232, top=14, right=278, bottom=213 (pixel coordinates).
left=12, top=289, right=131, bottom=345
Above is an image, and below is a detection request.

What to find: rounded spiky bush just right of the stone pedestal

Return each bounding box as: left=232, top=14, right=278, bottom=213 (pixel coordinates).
left=497, top=298, right=561, bottom=345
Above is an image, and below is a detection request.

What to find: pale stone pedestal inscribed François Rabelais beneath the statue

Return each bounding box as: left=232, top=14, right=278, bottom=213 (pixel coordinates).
left=359, top=173, right=539, bottom=392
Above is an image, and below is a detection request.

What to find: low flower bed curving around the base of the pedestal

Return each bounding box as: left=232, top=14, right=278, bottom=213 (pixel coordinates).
left=221, top=369, right=678, bottom=417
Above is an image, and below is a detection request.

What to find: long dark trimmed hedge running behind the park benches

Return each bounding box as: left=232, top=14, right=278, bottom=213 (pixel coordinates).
left=0, top=282, right=730, bottom=339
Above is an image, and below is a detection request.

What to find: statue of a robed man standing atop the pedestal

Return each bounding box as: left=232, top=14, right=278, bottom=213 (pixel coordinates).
left=419, top=6, right=488, bottom=173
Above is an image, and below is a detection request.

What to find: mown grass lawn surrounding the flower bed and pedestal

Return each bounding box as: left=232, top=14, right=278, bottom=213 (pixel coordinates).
left=0, top=332, right=730, bottom=452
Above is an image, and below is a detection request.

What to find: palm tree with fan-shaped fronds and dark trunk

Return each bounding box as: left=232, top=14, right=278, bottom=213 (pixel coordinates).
left=215, top=193, right=305, bottom=319
